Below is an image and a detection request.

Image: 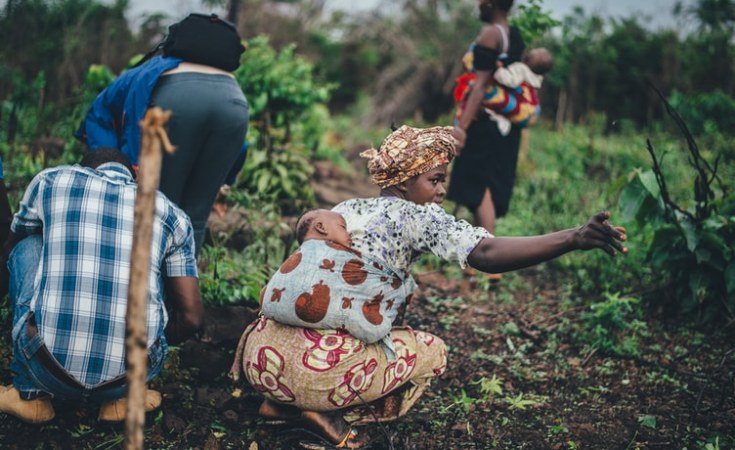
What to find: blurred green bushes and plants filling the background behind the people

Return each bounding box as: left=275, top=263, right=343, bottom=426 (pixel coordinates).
left=0, top=0, right=735, bottom=449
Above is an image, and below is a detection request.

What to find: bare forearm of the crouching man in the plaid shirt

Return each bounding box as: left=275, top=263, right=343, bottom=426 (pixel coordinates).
left=164, top=277, right=204, bottom=345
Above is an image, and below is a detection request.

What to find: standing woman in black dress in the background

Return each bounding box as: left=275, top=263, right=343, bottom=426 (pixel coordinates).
left=447, top=0, right=525, bottom=278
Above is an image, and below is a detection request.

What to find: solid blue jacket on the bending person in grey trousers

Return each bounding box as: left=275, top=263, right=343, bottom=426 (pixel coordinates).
left=75, top=56, right=181, bottom=166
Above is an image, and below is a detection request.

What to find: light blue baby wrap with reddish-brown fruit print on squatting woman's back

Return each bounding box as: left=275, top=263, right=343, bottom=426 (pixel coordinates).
left=260, top=240, right=416, bottom=342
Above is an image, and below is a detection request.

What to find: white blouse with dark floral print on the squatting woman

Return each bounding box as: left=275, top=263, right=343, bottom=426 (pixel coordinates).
left=333, top=197, right=493, bottom=271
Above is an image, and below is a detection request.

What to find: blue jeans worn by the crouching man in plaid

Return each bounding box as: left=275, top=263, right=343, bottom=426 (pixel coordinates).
left=8, top=235, right=167, bottom=402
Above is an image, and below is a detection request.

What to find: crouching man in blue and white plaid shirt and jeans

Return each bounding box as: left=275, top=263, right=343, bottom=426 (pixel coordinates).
left=0, top=149, right=203, bottom=423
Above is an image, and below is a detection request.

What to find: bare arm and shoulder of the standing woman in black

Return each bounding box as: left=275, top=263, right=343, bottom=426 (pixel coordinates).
left=452, top=26, right=502, bottom=150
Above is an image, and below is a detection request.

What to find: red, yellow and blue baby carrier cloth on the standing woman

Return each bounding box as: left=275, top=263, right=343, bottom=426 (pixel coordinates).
left=454, top=25, right=541, bottom=128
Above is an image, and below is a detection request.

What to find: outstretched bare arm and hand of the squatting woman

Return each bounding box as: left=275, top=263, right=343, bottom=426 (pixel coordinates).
left=467, top=212, right=628, bottom=273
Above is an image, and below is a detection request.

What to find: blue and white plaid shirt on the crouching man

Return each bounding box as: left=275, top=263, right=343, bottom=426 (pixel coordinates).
left=12, top=163, right=197, bottom=388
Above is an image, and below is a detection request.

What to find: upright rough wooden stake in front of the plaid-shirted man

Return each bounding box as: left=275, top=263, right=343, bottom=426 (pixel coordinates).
left=125, top=107, right=173, bottom=450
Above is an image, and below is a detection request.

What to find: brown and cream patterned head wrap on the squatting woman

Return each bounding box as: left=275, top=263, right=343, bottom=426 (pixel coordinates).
left=360, top=125, right=455, bottom=188
